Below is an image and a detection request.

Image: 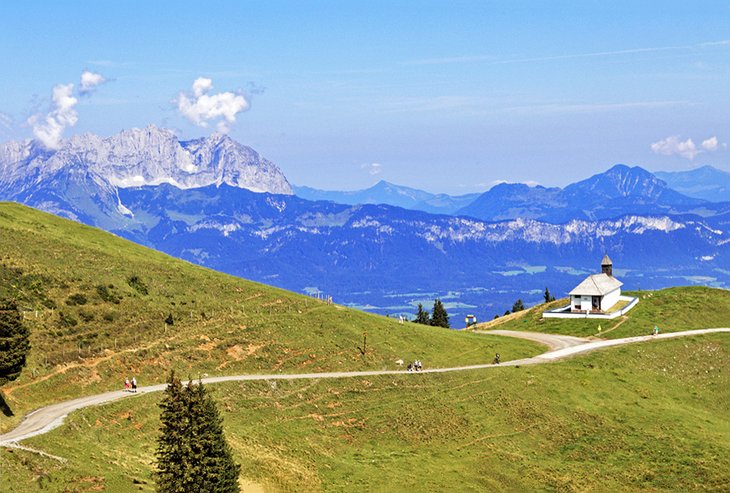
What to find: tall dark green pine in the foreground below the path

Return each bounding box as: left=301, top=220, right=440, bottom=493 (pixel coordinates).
left=156, top=373, right=241, bottom=493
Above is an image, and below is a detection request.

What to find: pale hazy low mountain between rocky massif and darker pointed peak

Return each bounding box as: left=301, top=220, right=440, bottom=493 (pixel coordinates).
left=293, top=180, right=479, bottom=214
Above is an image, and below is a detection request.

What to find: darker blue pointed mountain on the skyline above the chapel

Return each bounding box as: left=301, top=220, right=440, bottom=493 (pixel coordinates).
left=457, top=164, right=730, bottom=223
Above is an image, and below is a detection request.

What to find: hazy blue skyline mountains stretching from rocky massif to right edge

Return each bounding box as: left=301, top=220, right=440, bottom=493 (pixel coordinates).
left=293, top=164, right=730, bottom=224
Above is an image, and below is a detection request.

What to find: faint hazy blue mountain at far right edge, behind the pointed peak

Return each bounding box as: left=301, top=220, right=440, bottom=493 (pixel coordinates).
left=654, top=166, right=730, bottom=202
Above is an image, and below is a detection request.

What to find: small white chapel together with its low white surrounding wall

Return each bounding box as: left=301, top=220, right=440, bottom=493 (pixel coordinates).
left=542, top=255, right=639, bottom=318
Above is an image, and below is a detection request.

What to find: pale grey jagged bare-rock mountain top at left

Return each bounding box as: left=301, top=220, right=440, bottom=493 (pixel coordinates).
left=0, top=125, right=292, bottom=194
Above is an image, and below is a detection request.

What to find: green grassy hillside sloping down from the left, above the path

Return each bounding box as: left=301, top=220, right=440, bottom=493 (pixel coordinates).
left=0, top=203, right=543, bottom=431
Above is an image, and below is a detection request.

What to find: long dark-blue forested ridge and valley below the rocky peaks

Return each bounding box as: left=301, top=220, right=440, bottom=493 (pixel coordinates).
left=112, top=185, right=730, bottom=318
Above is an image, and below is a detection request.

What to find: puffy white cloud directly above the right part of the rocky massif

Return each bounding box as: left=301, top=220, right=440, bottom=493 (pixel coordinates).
left=177, top=77, right=249, bottom=133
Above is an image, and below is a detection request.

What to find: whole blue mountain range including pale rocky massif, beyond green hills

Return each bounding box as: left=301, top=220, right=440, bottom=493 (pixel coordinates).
left=0, top=127, right=730, bottom=319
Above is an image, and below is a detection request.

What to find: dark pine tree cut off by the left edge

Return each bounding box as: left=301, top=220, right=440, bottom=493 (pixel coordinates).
left=0, top=300, right=30, bottom=386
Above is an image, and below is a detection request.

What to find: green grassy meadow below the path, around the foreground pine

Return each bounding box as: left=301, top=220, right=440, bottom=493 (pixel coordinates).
left=0, top=334, right=730, bottom=492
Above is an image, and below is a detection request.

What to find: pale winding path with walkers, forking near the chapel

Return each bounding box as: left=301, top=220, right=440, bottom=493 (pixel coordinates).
left=0, top=328, right=730, bottom=446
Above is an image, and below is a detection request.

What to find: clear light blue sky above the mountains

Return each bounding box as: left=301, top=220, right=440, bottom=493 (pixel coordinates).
left=0, top=0, right=730, bottom=193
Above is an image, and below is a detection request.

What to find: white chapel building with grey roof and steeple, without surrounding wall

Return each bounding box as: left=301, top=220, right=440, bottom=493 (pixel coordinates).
left=569, top=255, right=623, bottom=313
